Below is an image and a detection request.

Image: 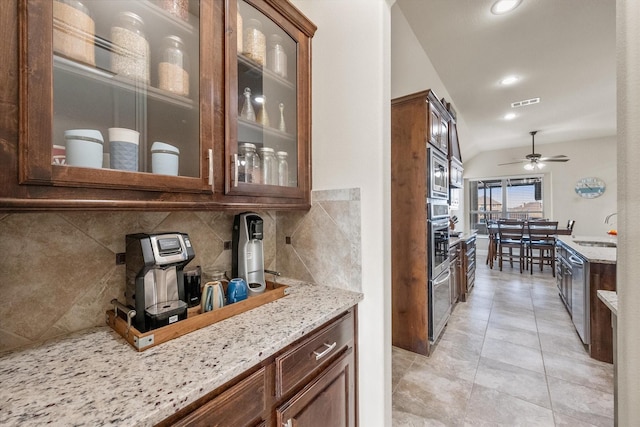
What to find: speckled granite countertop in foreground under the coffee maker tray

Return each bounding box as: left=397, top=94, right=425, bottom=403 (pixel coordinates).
left=0, top=279, right=363, bottom=426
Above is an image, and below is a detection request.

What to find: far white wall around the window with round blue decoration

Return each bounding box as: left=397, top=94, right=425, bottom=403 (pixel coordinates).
left=464, top=135, right=618, bottom=237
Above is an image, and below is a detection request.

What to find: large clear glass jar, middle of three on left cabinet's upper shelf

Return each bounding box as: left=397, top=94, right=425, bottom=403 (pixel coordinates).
left=111, top=12, right=149, bottom=84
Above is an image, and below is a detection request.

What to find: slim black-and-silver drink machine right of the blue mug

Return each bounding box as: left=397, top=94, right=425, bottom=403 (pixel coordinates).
left=231, top=212, right=266, bottom=297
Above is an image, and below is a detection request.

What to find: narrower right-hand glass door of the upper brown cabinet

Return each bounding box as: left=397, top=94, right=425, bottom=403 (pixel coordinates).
left=227, top=0, right=309, bottom=201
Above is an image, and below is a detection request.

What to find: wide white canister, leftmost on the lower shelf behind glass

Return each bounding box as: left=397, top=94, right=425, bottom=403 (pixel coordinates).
left=64, top=129, right=104, bottom=168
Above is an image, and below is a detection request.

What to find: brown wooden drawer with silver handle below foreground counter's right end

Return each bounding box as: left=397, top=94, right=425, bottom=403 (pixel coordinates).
left=275, top=311, right=354, bottom=397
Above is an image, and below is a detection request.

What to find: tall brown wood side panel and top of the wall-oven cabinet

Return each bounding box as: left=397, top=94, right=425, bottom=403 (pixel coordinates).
left=391, top=90, right=449, bottom=355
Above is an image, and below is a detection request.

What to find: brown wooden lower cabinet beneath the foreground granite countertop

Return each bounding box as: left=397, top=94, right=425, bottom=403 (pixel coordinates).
left=158, top=307, right=358, bottom=427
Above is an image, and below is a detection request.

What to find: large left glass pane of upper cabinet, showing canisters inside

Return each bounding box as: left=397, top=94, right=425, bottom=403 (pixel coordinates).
left=52, top=0, right=201, bottom=177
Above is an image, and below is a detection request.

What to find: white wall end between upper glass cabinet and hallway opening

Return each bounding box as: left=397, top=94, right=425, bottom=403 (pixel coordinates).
left=293, top=0, right=391, bottom=427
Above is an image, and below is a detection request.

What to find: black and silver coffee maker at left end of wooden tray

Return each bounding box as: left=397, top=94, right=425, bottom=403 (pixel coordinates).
left=125, top=233, right=195, bottom=332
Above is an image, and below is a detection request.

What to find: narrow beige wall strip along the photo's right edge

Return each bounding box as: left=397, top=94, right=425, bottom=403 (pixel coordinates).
left=616, top=0, right=640, bottom=426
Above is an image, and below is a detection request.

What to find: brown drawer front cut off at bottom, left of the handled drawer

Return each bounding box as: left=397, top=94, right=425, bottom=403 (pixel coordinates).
left=173, top=368, right=267, bottom=427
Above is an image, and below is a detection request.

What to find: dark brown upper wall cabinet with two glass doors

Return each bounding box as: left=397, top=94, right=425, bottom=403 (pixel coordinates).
left=0, top=0, right=316, bottom=211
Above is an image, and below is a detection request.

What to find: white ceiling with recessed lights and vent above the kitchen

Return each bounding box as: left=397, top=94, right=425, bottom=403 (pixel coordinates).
left=397, top=0, right=616, bottom=159
